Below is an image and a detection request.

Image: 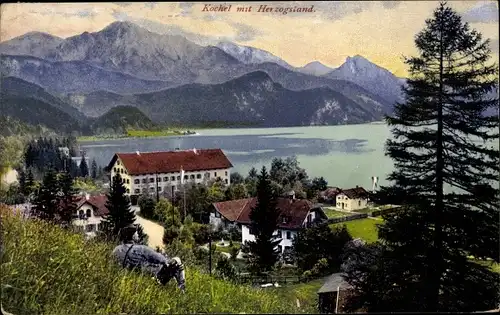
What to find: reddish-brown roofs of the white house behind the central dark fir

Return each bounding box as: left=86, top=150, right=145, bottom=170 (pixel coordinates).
left=213, top=197, right=322, bottom=229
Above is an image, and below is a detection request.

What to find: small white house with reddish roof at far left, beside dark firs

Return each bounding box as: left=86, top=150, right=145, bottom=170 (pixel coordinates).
left=73, top=194, right=109, bottom=236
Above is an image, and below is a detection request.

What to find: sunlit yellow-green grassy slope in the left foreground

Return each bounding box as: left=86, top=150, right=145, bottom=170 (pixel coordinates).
left=0, top=206, right=299, bottom=314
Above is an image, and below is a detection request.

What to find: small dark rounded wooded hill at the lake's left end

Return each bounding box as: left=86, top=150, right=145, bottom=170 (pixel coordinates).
left=91, top=106, right=155, bottom=134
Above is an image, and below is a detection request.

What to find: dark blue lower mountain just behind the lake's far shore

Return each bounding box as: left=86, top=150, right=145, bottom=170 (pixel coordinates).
left=65, top=71, right=381, bottom=127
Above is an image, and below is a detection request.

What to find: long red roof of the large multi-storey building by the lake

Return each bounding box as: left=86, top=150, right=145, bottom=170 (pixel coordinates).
left=108, top=149, right=233, bottom=175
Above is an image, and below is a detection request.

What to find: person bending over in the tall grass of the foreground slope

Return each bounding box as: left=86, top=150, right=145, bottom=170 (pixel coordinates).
left=113, top=224, right=186, bottom=292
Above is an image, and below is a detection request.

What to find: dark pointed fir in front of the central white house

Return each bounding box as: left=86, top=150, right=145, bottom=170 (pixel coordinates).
left=247, top=166, right=281, bottom=272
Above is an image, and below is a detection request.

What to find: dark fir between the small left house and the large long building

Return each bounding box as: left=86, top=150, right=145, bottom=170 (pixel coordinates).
left=103, top=173, right=135, bottom=238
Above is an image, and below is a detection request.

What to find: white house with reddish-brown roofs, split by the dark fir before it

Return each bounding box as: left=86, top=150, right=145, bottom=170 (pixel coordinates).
left=210, top=194, right=327, bottom=253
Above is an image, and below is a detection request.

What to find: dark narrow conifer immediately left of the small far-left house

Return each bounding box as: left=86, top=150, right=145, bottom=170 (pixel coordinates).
left=59, top=172, right=78, bottom=226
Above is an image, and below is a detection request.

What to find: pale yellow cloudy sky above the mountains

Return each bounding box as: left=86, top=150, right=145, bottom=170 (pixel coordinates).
left=0, top=1, right=499, bottom=77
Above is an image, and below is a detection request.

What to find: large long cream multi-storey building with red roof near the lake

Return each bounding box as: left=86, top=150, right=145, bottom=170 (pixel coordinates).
left=108, top=149, right=233, bottom=205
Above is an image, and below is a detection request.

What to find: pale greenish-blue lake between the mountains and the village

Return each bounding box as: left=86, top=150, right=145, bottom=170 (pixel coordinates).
left=80, top=123, right=393, bottom=189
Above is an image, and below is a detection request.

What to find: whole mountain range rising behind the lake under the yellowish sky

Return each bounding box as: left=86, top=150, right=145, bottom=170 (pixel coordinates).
left=0, top=22, right=404, bottom=130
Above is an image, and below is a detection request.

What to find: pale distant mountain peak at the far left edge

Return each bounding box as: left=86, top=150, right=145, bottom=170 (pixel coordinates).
left=0, top=32, right=64, bottom=58
